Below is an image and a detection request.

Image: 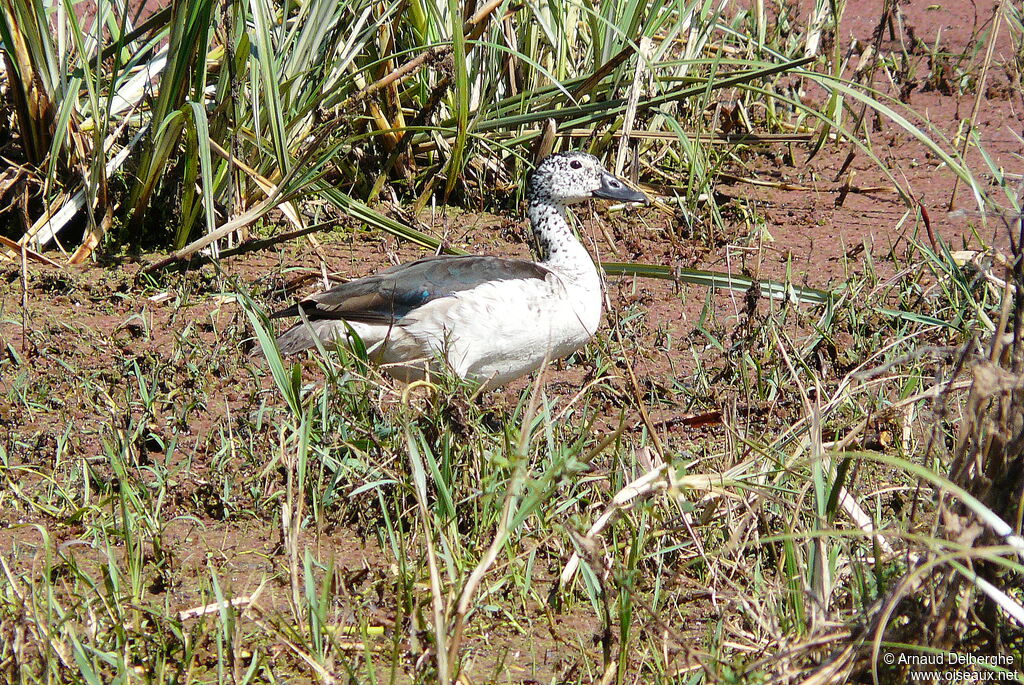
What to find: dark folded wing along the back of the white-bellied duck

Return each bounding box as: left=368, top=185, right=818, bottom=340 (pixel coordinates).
left=270, top=255, right=550, bottom=324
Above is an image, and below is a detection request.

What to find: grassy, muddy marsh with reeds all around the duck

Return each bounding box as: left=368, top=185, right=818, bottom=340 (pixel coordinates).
left=0, top=0, right=1024, bottom=683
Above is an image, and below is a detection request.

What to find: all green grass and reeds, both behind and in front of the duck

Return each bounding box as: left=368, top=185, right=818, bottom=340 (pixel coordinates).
left=0, top=0, right=1024, bottom=683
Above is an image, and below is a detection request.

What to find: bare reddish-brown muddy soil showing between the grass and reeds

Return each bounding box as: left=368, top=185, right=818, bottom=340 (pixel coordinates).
left=0, top=0, right=1024, bottom=682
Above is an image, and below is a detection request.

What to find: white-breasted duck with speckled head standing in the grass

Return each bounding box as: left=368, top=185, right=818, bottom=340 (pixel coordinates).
left=271, top=152, right=646, bottom=388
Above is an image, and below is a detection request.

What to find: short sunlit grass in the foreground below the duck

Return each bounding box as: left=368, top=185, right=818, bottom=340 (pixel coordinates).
left=0, top=211, right=1020, bottom=682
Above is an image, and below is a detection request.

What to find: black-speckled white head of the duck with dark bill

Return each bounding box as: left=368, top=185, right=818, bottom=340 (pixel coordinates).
left=526, top=152, right=647, bottom=205
